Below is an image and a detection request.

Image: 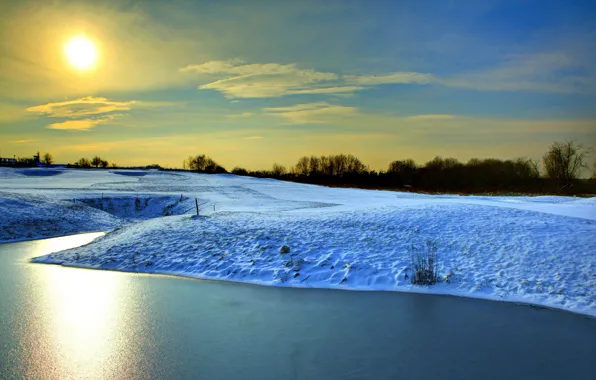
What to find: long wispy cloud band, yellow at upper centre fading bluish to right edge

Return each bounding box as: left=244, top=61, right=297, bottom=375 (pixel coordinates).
left=180, top=52, right=596, bottom=98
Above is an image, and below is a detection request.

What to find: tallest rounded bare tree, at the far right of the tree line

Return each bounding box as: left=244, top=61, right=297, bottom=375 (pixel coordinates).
left=542, top=141, right=592, bottom=186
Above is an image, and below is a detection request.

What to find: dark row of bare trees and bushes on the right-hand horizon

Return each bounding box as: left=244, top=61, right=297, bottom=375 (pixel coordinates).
left=183, top=141, right=596, bottom=194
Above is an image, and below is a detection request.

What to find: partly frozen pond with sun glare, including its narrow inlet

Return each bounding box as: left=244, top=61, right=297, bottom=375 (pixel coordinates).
left=0, top=234, right=596, bottom=380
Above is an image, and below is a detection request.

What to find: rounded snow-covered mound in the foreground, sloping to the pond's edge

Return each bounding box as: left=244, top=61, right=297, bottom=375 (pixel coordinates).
left=35, top=205, right=596, bottom=315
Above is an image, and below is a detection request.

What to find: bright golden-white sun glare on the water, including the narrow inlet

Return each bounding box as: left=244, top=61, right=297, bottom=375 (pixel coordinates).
left=23, top=235, right=140, bottom=379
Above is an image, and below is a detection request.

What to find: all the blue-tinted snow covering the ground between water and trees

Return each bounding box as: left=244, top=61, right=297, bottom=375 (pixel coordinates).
left=0, top=168, right=596, bottom=316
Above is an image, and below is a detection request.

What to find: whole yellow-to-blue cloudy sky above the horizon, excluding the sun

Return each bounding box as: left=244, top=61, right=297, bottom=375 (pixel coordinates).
left=0, top=0, right=596, bottom=170
